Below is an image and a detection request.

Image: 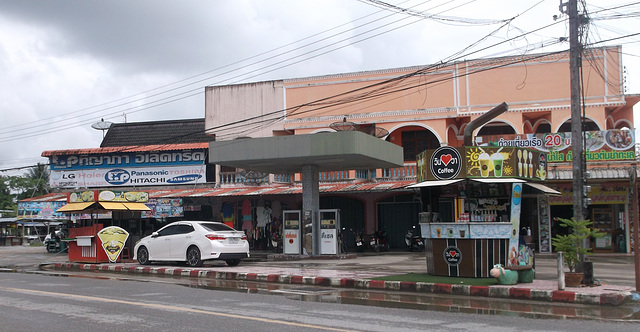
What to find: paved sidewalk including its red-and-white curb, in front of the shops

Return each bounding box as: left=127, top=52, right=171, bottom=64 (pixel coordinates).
left=30, top=249, right=637, bottom=306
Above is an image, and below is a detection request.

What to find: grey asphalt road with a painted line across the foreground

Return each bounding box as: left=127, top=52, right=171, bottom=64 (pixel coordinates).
left=0, top=273, right=638, bottom=332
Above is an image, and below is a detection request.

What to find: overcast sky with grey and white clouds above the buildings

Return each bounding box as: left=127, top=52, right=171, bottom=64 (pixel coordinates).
left=0, top=0, right=640, bottom=175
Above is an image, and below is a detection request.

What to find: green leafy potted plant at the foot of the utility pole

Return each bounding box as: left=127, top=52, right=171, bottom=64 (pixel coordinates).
left=551, top=217, right=604, bottom=287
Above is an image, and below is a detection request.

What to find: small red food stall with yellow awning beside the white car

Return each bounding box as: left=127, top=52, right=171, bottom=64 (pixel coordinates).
left=56, top=190, right=150, bottom=263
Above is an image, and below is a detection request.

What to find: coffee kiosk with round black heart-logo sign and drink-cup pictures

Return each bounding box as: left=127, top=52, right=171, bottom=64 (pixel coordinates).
left=409, top=146, right=554, bottom=278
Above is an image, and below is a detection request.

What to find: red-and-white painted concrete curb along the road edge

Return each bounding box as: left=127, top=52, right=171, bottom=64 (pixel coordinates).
left=48, top=263, right=633, bottom=306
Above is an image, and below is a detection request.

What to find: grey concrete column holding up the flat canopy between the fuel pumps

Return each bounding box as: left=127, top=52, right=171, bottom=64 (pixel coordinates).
left=302, top=165, right=320, bottom=256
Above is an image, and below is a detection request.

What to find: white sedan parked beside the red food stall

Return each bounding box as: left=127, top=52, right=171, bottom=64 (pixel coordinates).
left=133, top=221, right=249, bottom=266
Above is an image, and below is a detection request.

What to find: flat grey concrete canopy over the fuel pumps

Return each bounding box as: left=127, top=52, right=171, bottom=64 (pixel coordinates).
left=209, top=131, right=404, bottom=174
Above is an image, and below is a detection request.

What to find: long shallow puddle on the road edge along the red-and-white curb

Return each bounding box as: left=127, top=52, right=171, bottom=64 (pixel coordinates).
left=24, top=271, right=640, bottom=322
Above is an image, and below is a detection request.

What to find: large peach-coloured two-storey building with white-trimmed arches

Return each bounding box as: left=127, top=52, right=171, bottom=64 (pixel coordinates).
left=205, top=47, right=640, bottom=252
